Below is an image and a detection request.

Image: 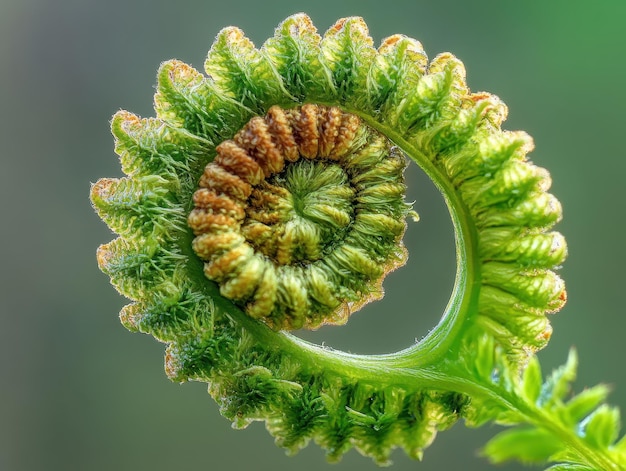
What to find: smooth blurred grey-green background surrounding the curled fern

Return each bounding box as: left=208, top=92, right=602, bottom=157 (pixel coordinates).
left=0, top=0, right=626, bottom=471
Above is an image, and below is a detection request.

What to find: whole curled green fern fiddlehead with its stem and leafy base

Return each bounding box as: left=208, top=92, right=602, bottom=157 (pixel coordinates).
left=91, top=14, right=626, bottom=470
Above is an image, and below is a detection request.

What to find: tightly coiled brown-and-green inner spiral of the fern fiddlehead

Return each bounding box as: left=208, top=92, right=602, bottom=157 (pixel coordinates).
left=188, top=104, right=409, bottom=330
